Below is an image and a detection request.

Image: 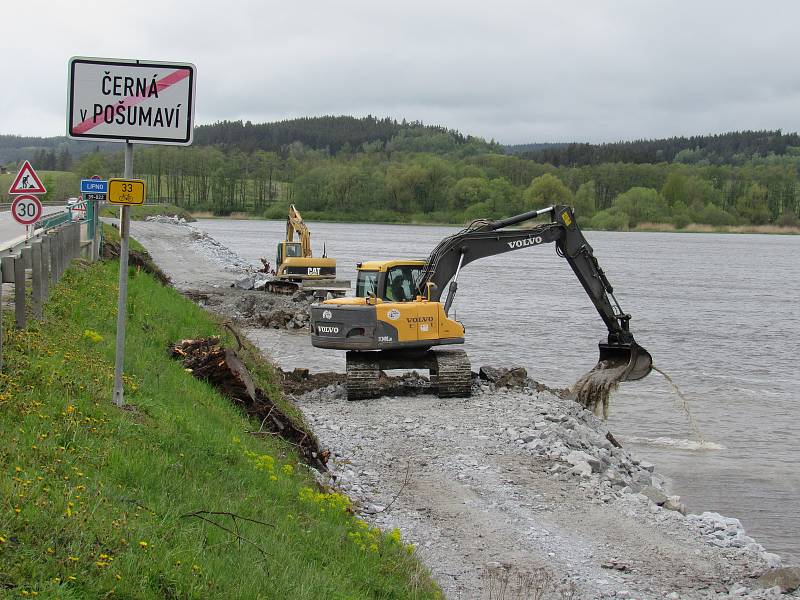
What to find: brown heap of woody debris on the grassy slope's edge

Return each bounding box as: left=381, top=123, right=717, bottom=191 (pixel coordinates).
left=170, top=337, right=328, bottom=470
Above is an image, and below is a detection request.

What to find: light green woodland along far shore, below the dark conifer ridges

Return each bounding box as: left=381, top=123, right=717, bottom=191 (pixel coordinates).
left=76, top=128, right=800, bottom=229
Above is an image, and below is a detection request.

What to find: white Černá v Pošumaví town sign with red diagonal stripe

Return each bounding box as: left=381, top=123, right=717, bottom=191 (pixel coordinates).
left=67, top=57, right=195, bottom=145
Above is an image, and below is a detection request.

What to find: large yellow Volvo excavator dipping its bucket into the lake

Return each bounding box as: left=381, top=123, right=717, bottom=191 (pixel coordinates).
left=311, top=206, right=652, bottom=400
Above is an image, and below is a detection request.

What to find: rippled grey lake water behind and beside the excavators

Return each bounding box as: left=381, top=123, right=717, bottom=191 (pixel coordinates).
left=198, top=220, right=800, bottom=563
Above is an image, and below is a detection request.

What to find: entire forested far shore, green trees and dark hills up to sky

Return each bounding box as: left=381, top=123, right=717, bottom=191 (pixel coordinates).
left=0, top=117, right=800, bottom=230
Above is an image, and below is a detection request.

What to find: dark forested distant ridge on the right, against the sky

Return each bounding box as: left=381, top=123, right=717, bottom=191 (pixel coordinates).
left=520, top=130, right=800, bottom=166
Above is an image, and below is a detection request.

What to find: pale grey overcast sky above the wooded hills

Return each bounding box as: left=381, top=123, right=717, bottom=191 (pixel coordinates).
left=0, top=0, right=800, bottom=143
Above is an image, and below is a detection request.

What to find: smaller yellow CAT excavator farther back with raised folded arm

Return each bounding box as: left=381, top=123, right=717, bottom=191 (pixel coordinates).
left=267, top=204, right=350, bottom=294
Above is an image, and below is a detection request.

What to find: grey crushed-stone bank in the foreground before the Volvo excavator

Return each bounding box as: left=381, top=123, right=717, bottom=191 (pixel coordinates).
left=297, top=382, right=779, bottom=599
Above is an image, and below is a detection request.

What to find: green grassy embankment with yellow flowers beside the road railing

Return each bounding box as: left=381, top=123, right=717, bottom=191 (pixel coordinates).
left=0, top=229, right=438, bottom=599
